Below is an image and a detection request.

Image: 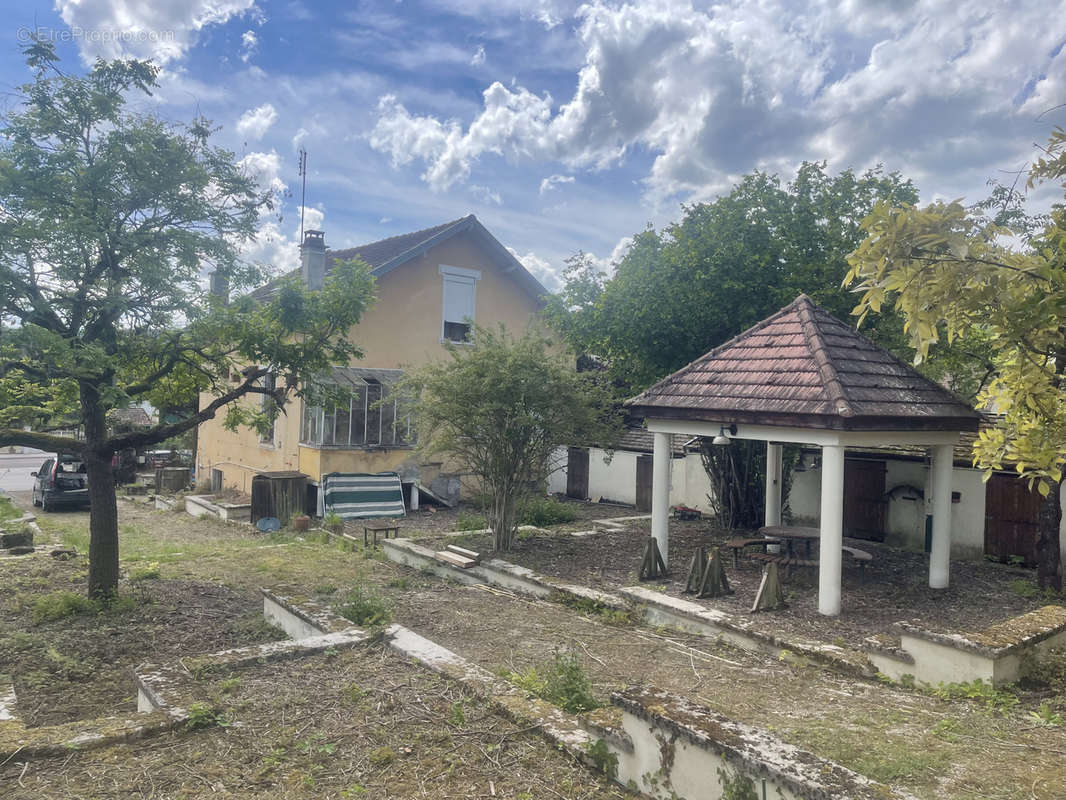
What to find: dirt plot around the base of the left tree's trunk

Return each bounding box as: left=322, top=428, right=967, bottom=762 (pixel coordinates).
left=0, top=555, right=284, bottom=726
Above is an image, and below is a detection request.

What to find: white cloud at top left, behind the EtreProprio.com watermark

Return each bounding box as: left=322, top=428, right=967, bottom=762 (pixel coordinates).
left=54, top=0, right=255, bottom=64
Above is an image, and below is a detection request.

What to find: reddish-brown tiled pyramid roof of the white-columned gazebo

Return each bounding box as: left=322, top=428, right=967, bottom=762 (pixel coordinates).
left=626, top=294, right=980, bottom=431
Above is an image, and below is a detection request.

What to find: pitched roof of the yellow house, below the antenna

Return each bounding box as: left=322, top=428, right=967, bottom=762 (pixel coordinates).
left=252, top=214, right=548, bottom=301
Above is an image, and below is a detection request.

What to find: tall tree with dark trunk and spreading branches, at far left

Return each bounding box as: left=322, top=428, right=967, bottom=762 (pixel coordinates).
left=0, top=43, right=372, bottom=596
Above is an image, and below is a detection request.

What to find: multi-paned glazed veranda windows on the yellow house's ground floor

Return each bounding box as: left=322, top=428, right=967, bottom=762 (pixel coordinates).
left=300, top=378, right=416, bottom=447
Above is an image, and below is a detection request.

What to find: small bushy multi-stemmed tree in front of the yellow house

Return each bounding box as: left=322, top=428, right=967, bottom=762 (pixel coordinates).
left=399, top=326, right=618, bottom=550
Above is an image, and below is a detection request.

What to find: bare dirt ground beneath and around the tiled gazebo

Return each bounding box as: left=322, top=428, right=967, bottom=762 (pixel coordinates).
left=430, top=521, right=1048, bottom=646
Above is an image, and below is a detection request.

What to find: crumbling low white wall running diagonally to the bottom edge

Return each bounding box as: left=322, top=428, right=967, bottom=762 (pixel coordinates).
left=263, top=588, right=907, bottom=800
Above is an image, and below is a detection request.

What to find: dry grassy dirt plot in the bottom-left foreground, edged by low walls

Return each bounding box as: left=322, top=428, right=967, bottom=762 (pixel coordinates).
left=0, top=647, right=626, bottom=800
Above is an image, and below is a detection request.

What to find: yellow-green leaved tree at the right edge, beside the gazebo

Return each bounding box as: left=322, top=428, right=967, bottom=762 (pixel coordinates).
left=846, top=129, right=1066, bottom=589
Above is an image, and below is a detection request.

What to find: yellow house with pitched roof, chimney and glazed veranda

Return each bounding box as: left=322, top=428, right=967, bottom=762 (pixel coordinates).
left=196, top=214, right=546, bottom=508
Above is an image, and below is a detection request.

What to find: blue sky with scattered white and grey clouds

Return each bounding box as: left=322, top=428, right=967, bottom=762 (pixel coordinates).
left=0, top=0, right=1066, bottom=287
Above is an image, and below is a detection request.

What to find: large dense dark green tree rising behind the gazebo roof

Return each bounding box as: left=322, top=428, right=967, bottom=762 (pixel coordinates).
left=547, top=163, right=918, bottom=389
